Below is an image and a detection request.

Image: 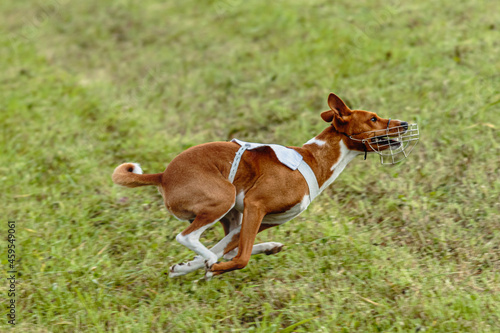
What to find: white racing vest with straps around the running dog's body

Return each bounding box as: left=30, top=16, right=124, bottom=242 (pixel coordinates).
left=228, top=139, right=320, bottom=203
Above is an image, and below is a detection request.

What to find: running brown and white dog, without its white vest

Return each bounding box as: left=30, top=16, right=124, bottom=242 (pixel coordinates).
left=112, top=93, right=408, bottom=279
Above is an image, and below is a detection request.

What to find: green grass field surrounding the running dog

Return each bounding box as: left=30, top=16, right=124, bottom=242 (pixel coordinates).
left=0, top=0, right=500, bottom=332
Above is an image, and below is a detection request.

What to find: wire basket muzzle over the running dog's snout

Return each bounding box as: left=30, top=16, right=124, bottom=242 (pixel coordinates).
left=349, top=123, right=419, bottom=164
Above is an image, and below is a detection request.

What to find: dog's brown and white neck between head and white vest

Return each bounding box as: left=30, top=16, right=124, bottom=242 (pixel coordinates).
left=300, top=126, right=363, bottom=192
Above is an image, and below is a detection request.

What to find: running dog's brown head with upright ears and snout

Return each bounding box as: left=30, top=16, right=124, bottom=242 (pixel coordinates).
left=321, top=93, right=408, bottom=152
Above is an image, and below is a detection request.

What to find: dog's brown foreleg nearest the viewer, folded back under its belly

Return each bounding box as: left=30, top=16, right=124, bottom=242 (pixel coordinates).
left=205, top=199, right=266, bottom=279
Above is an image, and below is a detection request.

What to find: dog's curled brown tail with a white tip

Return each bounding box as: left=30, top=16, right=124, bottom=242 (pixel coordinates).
left=111, top=163, right=163, bottom=187
